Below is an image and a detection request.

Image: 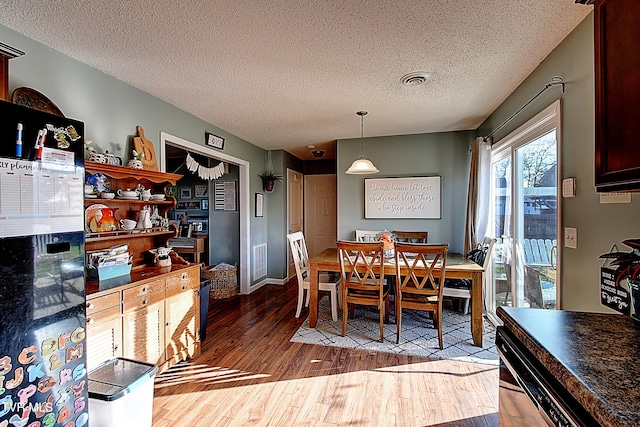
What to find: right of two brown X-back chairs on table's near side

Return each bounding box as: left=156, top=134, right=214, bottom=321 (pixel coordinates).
left=395, top=242, right=449, bottom=350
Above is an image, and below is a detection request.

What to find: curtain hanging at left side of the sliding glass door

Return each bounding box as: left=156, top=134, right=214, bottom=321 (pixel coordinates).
left=464, top=137, right=491, bottom=254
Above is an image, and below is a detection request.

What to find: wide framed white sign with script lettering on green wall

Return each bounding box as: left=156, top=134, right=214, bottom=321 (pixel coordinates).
left=364, top=176, right=441, bottom=219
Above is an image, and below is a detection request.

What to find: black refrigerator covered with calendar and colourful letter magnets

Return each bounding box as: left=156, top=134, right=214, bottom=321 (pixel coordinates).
left=0, top=101, right=89, bottom=427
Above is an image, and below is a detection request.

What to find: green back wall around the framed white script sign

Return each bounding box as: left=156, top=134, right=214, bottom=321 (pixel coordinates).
left=337, top=132, right=474, bottom=252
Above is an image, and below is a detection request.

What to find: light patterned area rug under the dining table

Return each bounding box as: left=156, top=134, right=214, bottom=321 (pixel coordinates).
left=290, top=297, right=498, bottom=365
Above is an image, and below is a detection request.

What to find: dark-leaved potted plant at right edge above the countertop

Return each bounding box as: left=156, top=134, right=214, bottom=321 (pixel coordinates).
left=600, top=239, right=640, bottom=320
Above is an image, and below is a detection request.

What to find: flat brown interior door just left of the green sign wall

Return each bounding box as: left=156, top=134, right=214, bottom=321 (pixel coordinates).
left=304, top=174, right=338, bottom=257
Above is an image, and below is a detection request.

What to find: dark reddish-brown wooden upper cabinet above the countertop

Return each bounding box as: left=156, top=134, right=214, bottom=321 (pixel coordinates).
left=594, top=0, right=640, bottom=192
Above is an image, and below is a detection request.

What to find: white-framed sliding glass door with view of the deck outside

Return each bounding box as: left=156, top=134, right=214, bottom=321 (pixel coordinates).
left=486, top=101, right=561, bottom=317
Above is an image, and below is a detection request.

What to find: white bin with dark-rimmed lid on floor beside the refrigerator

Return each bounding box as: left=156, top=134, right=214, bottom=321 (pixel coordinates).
left=89, top=357, right=158, bottom=427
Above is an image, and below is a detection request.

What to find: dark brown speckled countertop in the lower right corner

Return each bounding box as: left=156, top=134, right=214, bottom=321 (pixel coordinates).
left=497, top=307, right=640, bottom=426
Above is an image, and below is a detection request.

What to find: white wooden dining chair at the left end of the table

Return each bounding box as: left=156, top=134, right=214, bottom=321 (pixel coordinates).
left=287, top=231, right=340, bottom=322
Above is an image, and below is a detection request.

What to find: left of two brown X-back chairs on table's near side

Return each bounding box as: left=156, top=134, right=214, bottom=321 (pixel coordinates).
left=337, top=241, right=389, bottom=342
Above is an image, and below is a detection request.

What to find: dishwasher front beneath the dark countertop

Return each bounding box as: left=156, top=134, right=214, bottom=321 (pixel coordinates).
left=496, top=326, right=598, bottom=427
